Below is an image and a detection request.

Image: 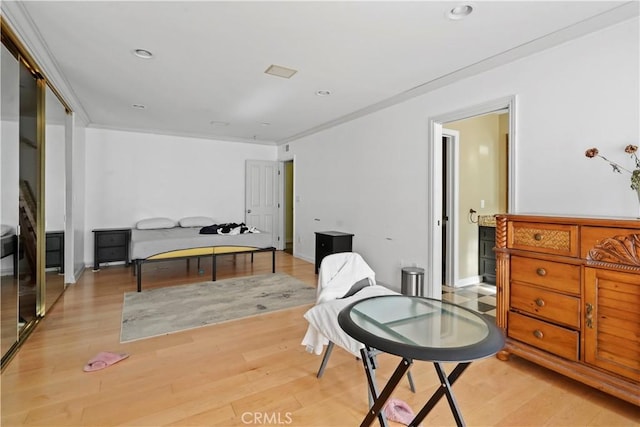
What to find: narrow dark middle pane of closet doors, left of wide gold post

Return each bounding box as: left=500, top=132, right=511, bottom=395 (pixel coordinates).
left=18, top=64, right=40, bottom=328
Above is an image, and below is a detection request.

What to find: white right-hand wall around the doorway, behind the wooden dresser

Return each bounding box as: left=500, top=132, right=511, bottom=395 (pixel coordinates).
left=279, top=18, right=640, bottom=287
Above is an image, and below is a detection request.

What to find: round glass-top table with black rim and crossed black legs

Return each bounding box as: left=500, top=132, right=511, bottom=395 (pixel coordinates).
left=338, top=295, right=504, bottom=426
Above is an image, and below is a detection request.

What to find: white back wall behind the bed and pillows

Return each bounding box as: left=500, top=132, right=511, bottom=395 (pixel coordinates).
left=84, top=128, right=277, bottom=264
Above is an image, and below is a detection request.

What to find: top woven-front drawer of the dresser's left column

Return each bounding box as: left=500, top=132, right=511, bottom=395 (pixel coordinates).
left=507, top=222, right=579, bottom=257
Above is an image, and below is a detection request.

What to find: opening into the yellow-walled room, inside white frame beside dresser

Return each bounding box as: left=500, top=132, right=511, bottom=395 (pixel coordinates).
left=442, top=110, right=509, bottom=287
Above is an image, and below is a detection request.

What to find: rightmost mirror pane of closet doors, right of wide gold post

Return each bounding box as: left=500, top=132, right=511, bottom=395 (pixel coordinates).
left=41, top=86, right=66, bottom=314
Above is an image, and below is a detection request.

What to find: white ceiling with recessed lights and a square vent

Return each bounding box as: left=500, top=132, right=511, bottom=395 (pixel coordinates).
left=2, top=0, right=639, bottom=144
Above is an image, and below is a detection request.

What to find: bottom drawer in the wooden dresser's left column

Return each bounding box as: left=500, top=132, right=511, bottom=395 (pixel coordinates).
left=507, top=311, right=580, bottom=361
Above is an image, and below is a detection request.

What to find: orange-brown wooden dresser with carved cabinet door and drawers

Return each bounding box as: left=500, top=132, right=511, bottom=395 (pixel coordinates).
left=495, top=215, right=640, bottom=406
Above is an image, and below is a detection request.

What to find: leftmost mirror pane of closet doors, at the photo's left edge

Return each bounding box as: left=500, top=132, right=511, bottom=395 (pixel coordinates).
left=0, top=45, right=20, bottom=356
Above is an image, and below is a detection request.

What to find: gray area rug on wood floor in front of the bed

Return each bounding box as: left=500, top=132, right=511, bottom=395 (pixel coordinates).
left=120, top=273, right=316, bottom=342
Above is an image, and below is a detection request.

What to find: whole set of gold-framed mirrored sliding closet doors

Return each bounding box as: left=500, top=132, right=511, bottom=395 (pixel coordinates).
left=0, top=17, right=70, bottom=368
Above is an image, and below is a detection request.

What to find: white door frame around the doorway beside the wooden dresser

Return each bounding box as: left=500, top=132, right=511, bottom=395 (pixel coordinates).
left=425, top=95, right=518, bottom=298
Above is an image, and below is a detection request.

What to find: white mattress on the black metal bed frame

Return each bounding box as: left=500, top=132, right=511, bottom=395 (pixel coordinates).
left=131, top=227, right=273, bottom=259
